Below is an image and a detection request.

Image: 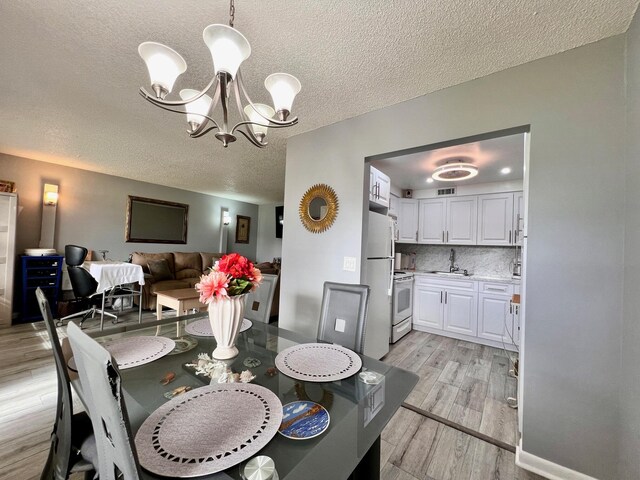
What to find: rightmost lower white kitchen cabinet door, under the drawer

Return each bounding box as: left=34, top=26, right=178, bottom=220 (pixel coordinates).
left=478, top=293, right=513, bottom=344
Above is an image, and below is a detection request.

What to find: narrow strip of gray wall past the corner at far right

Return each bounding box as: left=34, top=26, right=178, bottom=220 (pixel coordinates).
left=620, top=6, right=640, bottom=479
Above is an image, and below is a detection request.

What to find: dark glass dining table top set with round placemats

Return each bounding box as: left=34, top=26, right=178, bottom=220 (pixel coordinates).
left=85, top=312, right=418, bottom=480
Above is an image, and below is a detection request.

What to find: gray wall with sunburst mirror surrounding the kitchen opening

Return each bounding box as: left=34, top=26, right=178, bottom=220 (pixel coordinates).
left=280, top=36, right=625, bottom=479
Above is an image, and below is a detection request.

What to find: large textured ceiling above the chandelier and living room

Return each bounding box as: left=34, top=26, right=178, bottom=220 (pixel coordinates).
left=0, top=0, right=638, bottom=203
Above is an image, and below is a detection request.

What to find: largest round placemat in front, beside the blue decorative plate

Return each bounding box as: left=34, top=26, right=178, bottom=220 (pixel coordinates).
left=135, top=383, right=282, bottom=477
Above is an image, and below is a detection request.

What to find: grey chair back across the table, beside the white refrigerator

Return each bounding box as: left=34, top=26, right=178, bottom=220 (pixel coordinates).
left=318, top=282, right=369, bottom=354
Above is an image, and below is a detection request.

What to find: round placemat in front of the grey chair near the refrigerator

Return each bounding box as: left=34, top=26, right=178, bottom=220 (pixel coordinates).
left=276, top=343, right=362, bottom=382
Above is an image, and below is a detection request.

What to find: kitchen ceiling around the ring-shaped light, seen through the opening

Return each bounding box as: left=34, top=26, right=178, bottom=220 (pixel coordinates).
left=371, top=133, right=524, bottom=190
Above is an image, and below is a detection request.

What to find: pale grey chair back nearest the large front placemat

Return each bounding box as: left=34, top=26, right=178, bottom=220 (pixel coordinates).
left=67, top=322, right=141, bottom=480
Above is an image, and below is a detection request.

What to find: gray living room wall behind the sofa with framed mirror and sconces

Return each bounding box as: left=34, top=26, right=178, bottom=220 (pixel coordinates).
left=0, top=153, right=258, bottom=260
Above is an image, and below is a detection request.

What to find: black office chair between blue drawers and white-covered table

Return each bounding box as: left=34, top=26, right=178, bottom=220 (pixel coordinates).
left=58, top=245, right=118, bottom=328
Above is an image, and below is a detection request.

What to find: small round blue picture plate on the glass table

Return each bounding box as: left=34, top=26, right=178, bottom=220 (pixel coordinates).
left=278, top=401, right=330, bottom=440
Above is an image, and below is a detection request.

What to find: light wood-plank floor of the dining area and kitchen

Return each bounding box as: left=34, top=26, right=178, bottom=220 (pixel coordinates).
left=0, top=312, right=540, bottom=480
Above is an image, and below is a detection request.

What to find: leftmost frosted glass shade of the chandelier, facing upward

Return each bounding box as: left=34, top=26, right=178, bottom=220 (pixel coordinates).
left=138, top=42, right=187, bottom=98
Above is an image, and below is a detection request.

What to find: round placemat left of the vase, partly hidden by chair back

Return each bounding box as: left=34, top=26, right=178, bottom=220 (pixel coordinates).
left=103, top=336, right=176, bottom=370
